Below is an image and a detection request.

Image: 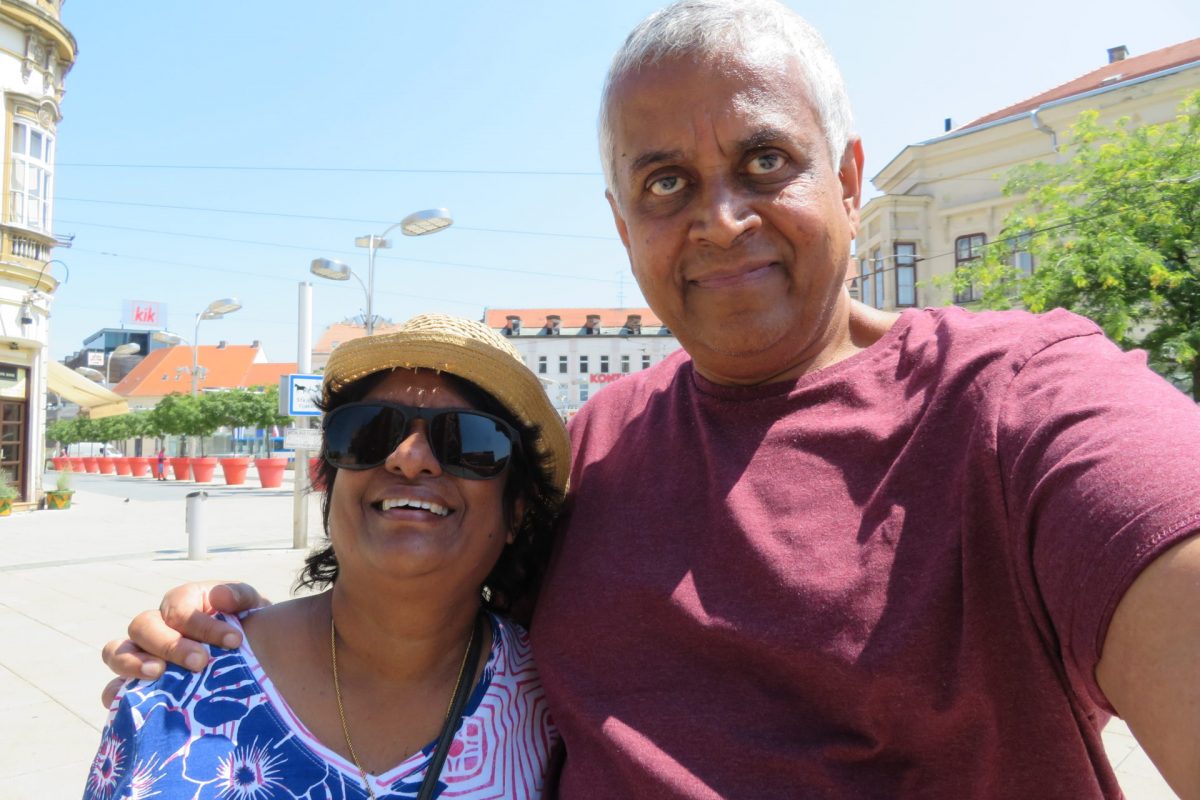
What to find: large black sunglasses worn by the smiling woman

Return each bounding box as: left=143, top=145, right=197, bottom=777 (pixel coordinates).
left=324, top=401, right=521, bottom=480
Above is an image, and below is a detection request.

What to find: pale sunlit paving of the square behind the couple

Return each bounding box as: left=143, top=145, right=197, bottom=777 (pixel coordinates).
left=0, top=475, right=1175, bottom=800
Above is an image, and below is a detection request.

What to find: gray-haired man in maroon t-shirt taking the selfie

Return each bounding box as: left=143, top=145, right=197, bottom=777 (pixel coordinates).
left=110, top=0, right=1200, bottom=799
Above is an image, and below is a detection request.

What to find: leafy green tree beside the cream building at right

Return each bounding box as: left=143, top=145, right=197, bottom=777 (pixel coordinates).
left=953, top=92, right=1200, bottom=401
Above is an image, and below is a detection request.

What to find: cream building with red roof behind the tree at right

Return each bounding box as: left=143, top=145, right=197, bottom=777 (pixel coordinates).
left=852, top=38, right=1200, bottom=309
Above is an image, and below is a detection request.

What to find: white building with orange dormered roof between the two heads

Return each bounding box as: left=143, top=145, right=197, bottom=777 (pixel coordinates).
left=484, top=308, right=679, bottom=419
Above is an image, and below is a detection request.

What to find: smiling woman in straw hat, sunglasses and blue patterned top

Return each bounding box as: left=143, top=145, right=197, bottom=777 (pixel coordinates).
left=85, top=314, right=570, bottom=800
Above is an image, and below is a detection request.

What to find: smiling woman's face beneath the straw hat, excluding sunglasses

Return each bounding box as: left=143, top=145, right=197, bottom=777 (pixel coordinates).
left=329, top=369, right=520, bottom=591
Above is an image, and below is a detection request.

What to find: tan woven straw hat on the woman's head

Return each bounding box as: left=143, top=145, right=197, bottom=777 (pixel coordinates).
left=320, top=314, right=571, bottom=492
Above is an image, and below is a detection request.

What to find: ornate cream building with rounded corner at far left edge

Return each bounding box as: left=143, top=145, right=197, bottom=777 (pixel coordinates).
left=0, top=0, right=78, bottom=501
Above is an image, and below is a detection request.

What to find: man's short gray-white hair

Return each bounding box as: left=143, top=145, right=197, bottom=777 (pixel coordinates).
left=599, top=0, right=854, bottom=194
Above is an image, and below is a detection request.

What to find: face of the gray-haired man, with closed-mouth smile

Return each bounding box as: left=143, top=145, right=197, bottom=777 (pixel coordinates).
left=608, top=56, right=862, bottom=384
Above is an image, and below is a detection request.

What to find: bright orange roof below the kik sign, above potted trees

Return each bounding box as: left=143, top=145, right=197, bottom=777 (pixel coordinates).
left=113, top=344, right=296, bottom=397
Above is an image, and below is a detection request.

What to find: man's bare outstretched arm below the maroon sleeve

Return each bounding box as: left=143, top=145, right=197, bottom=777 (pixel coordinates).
left=1096, top=533, right=1200, bottom=800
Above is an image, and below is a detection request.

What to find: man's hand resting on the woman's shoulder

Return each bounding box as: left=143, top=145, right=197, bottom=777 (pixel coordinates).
left=101, top=582, right=270, bottom=706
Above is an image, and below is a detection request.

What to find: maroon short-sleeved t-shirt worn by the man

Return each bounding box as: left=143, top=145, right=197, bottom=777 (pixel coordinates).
left=533, top=303, right=1200, bottom=800
